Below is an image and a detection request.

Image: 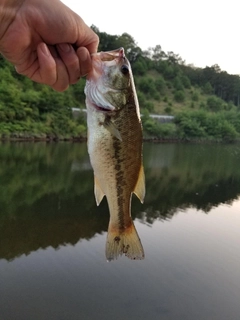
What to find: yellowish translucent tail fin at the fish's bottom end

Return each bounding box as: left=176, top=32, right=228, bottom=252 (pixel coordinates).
left=106, top=218, right=144, bottom=261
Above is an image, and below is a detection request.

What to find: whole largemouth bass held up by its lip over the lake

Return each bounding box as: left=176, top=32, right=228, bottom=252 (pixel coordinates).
left=84, top=48, right=145, bottom=261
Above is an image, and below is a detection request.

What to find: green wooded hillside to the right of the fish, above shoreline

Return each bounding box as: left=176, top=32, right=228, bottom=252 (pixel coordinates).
left=92, top=26, right=240, bottom=142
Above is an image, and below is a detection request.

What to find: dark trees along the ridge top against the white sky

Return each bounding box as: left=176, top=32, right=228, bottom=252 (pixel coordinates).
left=92, top=26, right=240, bottom=106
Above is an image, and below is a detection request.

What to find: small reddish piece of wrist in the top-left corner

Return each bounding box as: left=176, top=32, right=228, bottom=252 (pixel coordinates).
left=0, top=0, right=24, bottom=43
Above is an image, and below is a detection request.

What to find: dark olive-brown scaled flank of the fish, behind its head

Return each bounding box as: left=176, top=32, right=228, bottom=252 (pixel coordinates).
left=110, top=105, right=142, bottom=229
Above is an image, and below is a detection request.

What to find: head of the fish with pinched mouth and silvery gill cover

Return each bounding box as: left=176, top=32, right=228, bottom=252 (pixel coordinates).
left=85, top=48, right=132, bottom=111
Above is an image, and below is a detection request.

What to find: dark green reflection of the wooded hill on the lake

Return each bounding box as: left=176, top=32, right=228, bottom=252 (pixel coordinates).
left=0, top=143, right=240, bottom=260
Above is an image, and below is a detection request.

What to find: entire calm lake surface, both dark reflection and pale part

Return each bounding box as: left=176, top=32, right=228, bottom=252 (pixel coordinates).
left=0, top=142, right=240, bottom=320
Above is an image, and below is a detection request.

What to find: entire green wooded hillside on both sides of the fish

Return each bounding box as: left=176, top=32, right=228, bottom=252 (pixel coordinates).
left=0, top=26, right=240, bottom=141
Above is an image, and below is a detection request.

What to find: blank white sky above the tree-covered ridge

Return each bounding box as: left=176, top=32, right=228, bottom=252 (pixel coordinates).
left=62, top=0, right=240, bottom=74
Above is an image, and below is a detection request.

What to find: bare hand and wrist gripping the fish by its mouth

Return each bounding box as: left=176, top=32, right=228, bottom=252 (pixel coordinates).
left=0, top=0, right=98, bottom=91
